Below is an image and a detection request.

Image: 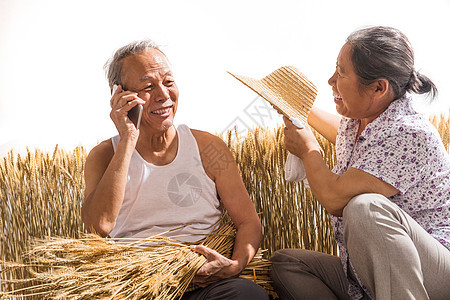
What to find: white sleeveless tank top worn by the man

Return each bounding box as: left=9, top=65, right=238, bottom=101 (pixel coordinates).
left=110, top=125, right=223, bottom=242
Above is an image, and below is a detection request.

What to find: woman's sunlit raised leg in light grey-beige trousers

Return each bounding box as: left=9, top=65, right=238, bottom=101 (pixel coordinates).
left=343, top=194, right=450, bottom=299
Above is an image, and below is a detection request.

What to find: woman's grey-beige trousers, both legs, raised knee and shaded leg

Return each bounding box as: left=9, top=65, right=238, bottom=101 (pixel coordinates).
left=271, top=194, right=450, bottom=300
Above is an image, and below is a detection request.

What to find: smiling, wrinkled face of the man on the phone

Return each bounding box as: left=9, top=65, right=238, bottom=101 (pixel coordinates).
left=121, top=49, right=178, bottom=131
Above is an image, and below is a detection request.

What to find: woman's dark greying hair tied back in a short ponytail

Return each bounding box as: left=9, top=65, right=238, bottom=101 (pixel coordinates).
left=347, top=26, right=437, bottom=99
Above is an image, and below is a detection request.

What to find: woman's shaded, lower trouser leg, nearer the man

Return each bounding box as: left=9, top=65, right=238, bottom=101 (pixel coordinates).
left=270, top=249, right=349, bottom=300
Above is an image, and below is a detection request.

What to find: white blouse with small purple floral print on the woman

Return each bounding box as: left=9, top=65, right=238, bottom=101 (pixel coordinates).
left=331, top=95, right=450, bottom=299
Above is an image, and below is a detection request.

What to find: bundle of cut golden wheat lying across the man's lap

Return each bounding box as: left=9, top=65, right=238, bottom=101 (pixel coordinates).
left=0, top=222, right=271, bottom=300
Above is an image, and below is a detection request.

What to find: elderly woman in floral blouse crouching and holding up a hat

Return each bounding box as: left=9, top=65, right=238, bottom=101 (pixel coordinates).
left=271, top=27, right=450, bottom=299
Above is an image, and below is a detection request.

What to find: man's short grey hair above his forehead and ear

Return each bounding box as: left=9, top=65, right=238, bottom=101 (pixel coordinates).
left=104, top=39, right=164, bottom=87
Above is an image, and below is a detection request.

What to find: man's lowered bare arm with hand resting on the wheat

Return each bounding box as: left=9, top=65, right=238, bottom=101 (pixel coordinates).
left=193, top=131, right=262, bottom=284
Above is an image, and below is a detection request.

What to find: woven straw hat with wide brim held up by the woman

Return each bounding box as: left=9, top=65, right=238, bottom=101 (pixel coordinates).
left=228, top=66, right=317, bottom=123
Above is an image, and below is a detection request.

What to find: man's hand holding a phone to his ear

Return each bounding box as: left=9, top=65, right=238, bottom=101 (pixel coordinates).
left=110, top=85, right=145, bottom=141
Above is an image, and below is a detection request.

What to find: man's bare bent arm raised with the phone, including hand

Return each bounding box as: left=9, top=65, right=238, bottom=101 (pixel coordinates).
left=81, top=86, right=145, bottom=236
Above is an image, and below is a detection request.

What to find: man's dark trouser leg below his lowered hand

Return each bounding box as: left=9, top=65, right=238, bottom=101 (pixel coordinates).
left=182, top=277, right=269, bottom=300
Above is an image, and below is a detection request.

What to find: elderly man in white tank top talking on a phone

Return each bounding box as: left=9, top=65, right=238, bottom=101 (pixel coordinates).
left=82, top=40, right=268, bottom=300
